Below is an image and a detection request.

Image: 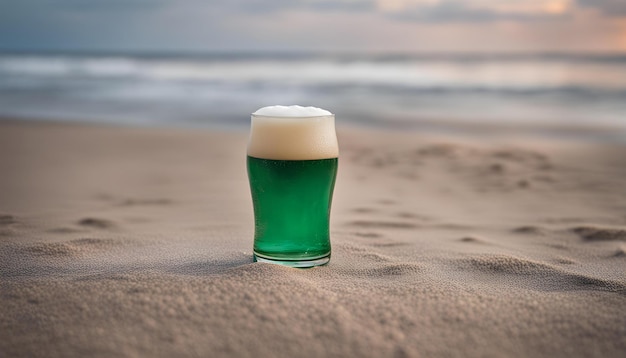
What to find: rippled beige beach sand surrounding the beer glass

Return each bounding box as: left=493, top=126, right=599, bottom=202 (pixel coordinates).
left=0, top=121, right=626, bottom=357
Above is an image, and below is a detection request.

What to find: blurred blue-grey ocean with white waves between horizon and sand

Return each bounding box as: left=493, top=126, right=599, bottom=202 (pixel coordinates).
left=0, top=53, right=626, bottom=138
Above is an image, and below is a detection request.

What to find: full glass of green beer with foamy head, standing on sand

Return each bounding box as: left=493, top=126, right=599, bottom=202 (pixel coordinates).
left=247, top=106, right=339, bottom=267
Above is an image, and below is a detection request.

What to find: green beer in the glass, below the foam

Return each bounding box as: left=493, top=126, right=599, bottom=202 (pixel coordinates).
left=248, top=156, right=337, bottom=261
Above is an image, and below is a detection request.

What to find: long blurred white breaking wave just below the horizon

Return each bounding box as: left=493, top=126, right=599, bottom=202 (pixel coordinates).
left=0, top=55, right=626, bottom=91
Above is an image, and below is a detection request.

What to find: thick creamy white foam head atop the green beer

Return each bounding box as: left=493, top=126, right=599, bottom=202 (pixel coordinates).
left=248, top=106, right=339, bottom=160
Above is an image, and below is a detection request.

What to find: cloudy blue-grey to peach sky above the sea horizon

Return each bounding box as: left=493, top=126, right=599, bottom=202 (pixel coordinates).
left=0, top=0, right=626, bottom=53
